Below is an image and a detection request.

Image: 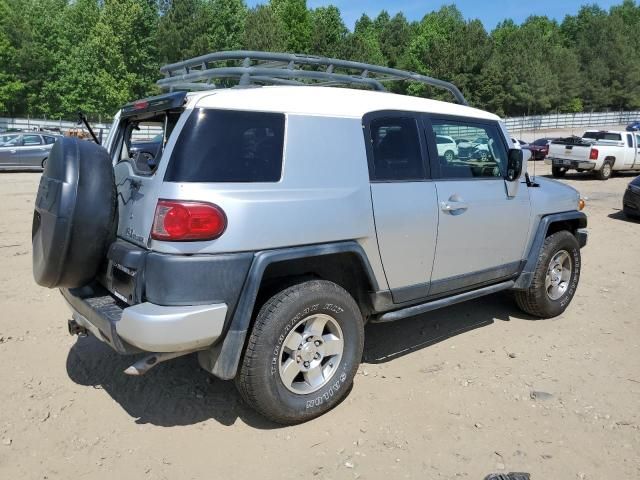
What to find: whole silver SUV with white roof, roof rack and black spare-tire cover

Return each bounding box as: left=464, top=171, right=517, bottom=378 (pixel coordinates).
left=33, top=52, right=587, bottom=423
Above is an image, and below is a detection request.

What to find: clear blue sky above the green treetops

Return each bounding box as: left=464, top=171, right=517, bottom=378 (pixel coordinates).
left=247, top=0, right=622, bottom=30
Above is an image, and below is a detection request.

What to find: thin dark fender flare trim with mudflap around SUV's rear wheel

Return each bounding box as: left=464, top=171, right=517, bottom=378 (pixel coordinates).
left=198, top=241, right=378, bottom=380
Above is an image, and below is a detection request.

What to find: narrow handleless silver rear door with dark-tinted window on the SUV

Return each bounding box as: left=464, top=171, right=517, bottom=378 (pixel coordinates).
left=363, top=112, right=444, bottom=303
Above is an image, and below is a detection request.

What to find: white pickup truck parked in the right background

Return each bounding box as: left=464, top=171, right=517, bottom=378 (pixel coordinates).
left=545, top=130, right=640, bottom=180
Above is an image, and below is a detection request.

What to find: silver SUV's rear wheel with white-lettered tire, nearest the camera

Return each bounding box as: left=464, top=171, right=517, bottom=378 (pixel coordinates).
left=236, top=280, right=364, bottom=425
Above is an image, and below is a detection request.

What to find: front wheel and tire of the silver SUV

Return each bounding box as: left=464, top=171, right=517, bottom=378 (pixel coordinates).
left=515, top=230, right=582, bottom=318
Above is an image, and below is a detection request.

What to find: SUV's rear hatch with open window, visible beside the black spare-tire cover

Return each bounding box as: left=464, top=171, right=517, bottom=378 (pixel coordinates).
left=99, top=92, right=186, bottom=304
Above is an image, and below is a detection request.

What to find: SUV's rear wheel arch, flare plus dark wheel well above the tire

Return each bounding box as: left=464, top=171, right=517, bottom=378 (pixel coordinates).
left=199, top=241, right=379, bottom=380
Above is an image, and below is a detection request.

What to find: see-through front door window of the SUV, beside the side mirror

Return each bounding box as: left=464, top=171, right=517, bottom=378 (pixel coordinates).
left=431, top=119, right=507, bottom=178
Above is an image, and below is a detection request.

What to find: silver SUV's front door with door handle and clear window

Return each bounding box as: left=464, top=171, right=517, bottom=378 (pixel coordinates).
left=427, top=117, right=530, bottom=295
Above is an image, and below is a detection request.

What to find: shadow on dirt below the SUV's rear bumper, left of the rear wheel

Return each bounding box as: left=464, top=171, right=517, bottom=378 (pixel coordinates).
left=67, top=336, right=279, bottom=429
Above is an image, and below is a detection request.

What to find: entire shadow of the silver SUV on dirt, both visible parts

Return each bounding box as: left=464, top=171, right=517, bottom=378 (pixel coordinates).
left=66, top=292, right=532, bottom=429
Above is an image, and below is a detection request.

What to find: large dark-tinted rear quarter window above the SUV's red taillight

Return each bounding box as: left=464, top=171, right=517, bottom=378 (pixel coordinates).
left=165, top=109, right=285, bottom=183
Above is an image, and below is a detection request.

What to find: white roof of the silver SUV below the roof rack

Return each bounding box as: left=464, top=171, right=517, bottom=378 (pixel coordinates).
left=189, top=86, right=500, bottom=120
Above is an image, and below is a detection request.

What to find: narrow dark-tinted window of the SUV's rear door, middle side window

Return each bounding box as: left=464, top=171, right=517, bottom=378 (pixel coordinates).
left=369, top=117, right=426, bottom=181
